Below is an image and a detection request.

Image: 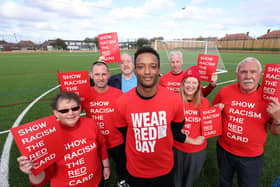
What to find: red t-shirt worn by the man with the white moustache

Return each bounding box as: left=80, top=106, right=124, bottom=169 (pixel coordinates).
left=213, top=83, right=270, bottom=157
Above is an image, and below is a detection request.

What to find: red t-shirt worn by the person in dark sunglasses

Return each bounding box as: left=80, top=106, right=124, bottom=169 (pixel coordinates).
left=31, top=117, right=108, bottom=187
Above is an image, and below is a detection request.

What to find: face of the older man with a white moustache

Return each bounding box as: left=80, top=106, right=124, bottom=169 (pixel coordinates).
left=236, top=61, right=261, bottom=93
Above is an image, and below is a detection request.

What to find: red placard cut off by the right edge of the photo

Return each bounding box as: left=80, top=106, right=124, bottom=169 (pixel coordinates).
left=262, top=64, right=280, bottom=102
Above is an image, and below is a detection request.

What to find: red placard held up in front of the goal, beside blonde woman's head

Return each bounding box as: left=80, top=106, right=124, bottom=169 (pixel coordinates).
left=197, top=54, right=219, bottom=82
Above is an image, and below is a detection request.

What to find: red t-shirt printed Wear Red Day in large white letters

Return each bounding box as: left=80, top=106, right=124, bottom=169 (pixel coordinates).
left=116, top=86, right=184, bottom=178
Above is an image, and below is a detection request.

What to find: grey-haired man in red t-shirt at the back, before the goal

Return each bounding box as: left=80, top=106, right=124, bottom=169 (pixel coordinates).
left=159, top=51, right=218, bottom=97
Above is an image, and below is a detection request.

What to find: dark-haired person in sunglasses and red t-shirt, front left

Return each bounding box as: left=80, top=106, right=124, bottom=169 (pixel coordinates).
left=17, top=92, right=110, bottom=187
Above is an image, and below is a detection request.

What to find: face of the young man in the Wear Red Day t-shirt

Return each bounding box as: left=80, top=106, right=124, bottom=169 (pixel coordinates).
left=135, top=53, right=160, bottom=88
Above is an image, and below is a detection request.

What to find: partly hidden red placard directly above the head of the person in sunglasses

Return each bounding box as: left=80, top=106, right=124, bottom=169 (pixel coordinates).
left=57, top=71, right=91, bottom=104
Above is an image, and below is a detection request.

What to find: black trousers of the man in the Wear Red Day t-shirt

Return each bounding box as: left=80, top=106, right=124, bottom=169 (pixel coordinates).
left=128, top=170, right=174, bottom=187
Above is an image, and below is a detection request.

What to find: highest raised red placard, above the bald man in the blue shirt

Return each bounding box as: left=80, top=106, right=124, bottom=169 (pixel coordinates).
left=98, top=32, right=121, bottom=63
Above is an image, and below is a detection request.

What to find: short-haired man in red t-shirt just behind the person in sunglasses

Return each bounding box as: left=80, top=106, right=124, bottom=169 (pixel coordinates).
left=85, top=61, right=129, bottom=187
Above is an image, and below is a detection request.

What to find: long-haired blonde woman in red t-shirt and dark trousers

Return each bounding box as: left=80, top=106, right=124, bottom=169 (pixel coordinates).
left=174, top=66, right=210, bottom=187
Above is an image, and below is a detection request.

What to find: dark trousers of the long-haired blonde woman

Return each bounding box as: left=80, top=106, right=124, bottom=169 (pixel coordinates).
left=173, top=148, right=207, bottom=187
